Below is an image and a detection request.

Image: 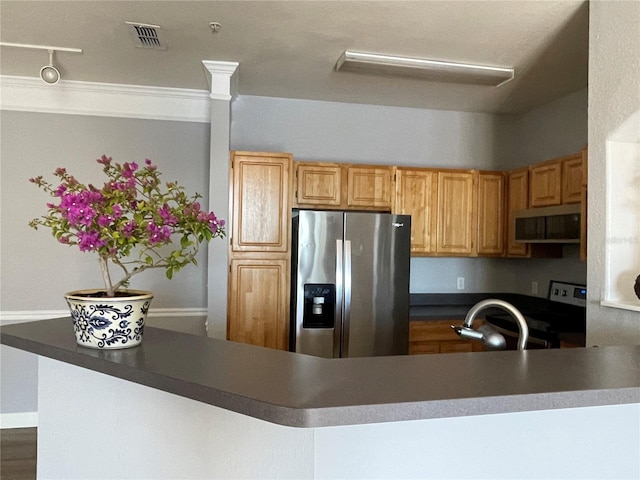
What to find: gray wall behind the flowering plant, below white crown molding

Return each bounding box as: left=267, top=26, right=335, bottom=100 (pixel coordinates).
left=0, top=110, right=210, bottom=311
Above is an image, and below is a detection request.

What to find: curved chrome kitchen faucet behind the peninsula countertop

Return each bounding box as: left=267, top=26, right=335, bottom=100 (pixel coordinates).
left=451, top=298, right=529, bottom=350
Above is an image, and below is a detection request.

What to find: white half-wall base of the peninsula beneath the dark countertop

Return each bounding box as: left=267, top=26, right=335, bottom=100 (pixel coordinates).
left=38, top=357, right=640, bottom=480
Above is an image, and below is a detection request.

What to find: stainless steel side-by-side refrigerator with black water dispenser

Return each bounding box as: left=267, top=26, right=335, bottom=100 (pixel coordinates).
left=290, top=210, right=411, bottom=358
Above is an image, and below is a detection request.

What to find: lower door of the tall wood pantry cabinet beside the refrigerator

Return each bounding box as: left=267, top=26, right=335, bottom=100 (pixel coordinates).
left=227, top=259, right=290, bottom=350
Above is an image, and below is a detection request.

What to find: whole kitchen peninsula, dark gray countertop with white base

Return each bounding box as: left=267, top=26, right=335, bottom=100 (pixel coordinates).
left=1, top=318, right=640, bottom=478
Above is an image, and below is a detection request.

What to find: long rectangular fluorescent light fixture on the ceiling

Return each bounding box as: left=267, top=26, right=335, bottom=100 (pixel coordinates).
left=336, top=50, right=514, bottom=87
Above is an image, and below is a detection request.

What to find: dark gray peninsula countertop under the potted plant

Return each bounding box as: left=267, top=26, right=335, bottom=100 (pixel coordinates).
left=0, top=318, right=640, bottom=427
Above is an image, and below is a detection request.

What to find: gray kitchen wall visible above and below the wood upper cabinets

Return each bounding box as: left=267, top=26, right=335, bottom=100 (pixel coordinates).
left=231, top=90, right=587, bottom=297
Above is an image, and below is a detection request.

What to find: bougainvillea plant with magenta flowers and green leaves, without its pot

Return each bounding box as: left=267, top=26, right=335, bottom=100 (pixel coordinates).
left=29, top=155, right=225, bottom=297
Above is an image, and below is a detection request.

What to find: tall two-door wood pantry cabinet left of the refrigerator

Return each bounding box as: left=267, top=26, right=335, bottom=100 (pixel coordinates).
left=227, top=151, right=293, bottom=350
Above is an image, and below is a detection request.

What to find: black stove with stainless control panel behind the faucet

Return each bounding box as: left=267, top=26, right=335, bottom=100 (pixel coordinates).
left=485, top=280, right=587, bottom=349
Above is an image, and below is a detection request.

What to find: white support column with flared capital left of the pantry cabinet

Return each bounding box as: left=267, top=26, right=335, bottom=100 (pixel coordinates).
left=202, top=60, right=239, bottom=339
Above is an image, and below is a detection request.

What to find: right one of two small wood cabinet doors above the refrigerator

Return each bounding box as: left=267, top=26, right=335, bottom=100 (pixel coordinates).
left=346, top=165, right=391, bottom=211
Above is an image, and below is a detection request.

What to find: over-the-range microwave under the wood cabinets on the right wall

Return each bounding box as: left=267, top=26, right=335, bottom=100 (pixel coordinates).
left=515, top=204, right=580, bottom=243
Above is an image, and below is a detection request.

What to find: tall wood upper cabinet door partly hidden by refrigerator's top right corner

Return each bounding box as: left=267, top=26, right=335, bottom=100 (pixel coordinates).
left=393, top=168, right=437, bottom=255
